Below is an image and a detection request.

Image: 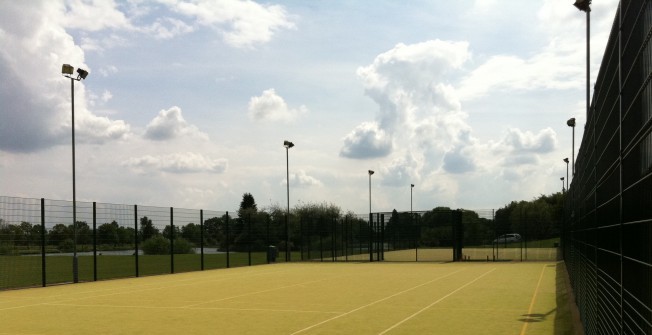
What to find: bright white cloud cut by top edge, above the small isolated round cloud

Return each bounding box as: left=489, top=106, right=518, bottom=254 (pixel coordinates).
left=167, top=0, right=295, bottom=48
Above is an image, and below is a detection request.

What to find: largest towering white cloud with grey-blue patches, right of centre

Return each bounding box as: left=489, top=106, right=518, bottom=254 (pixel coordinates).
left=341, top=40, right=473, bottom=173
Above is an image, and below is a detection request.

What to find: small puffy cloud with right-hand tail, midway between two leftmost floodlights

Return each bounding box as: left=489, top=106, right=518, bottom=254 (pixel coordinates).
left=145, top=106, right=208, bottom=141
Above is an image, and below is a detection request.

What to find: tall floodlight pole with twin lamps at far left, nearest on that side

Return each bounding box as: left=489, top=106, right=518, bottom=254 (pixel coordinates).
left=61, top=64, right=88, bottom=283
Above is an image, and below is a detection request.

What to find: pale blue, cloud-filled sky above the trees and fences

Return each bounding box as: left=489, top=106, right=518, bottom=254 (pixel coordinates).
left=0, top=0, right=618, bottom=213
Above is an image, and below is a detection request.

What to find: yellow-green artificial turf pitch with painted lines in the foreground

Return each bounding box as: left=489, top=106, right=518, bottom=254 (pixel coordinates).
left=0, top=262, right=578, bottom=335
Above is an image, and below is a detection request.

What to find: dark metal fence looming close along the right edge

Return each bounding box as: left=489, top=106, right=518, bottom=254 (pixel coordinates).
left=563, top=0, right=652, bottom=334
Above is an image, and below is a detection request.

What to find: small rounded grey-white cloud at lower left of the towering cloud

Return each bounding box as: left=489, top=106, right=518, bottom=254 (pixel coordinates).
left=340, top=122, right=392, bottom=159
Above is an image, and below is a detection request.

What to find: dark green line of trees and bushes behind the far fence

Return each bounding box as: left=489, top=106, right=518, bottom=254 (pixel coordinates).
left=0, top=193, right=564, bottom=254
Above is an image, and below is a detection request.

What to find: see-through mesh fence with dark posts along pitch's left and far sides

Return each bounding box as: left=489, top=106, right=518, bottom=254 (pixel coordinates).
left=0, top=196, right=558, bottom=289
